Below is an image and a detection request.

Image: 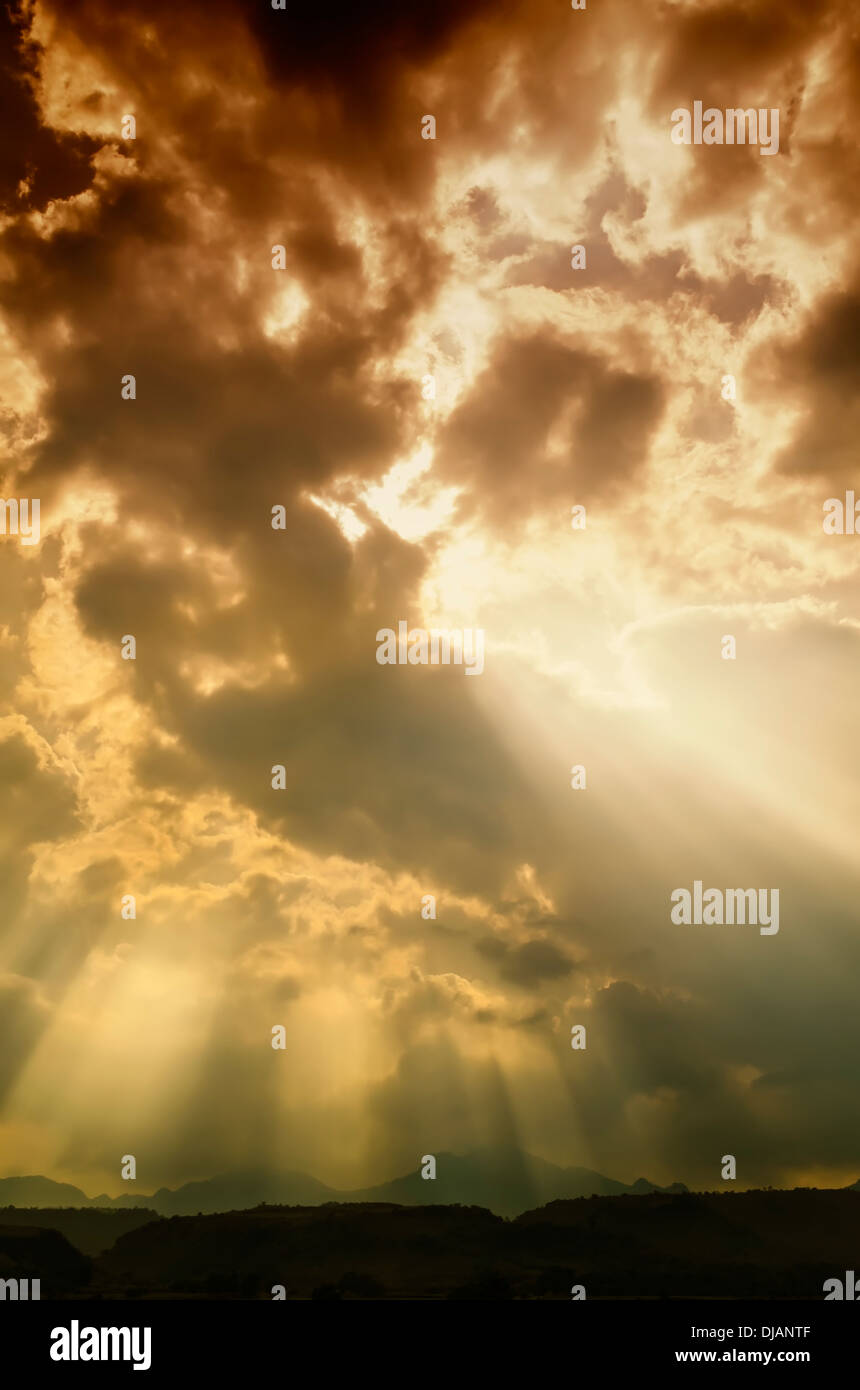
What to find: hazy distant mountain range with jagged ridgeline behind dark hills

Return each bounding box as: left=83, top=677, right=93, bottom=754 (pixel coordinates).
left=0, top=1147, right=686, bottom=1216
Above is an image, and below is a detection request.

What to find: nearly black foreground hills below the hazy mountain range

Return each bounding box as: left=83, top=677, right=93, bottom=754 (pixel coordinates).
left=0, top=1188, right=860, bottom=1300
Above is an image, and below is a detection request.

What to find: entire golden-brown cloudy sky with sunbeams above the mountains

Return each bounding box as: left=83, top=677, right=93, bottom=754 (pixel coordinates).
left=0, top=0, right=860, bottom=1193
